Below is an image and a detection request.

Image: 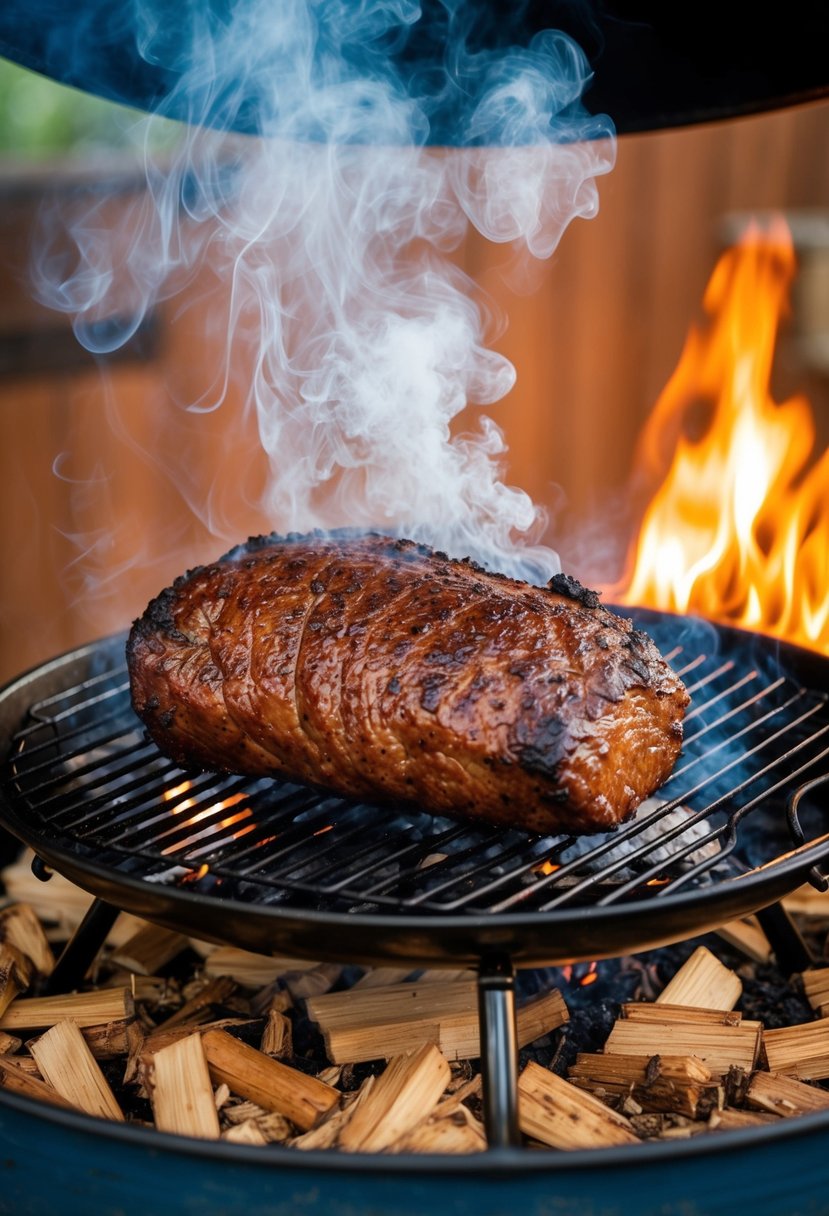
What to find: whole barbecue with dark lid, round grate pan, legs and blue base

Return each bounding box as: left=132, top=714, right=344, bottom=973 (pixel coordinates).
left=0, top=0, right=829, bottom=1216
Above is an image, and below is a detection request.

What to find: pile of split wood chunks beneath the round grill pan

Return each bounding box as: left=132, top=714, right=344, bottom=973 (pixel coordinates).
left=0, top=857, right=829, bottom=1153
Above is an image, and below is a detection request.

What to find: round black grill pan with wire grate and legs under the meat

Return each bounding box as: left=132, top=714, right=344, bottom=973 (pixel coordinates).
left=0, top=610, right=829, bottom=1147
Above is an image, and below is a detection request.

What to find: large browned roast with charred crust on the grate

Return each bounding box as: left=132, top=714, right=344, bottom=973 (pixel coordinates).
left=128, top=533, right=688, bottom=833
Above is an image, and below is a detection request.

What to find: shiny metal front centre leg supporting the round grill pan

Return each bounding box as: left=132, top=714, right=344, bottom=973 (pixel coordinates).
left=478, top=956, right=521, bottom=1148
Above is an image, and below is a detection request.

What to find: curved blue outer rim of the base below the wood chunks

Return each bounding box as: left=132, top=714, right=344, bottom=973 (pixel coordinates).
left=0, top=1092, right=829, bottom=1216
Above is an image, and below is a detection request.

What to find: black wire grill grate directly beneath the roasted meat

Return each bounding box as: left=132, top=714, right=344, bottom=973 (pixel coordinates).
left=2, top=617, right=829, bottom=916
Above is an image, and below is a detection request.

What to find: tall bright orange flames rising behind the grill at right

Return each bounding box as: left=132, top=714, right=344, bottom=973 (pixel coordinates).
left=607, top=218, right=829, bottom=653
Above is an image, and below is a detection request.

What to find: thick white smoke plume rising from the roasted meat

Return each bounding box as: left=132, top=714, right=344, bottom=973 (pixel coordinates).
left=35, top=0, right=614, bottom=576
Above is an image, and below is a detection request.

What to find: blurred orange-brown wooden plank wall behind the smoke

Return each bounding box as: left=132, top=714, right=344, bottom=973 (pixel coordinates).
left=0, top=103, right=829, bottom=680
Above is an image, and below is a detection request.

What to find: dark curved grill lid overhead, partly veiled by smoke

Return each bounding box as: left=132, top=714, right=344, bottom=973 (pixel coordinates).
left=0, top=0, right=829, bottom=145
